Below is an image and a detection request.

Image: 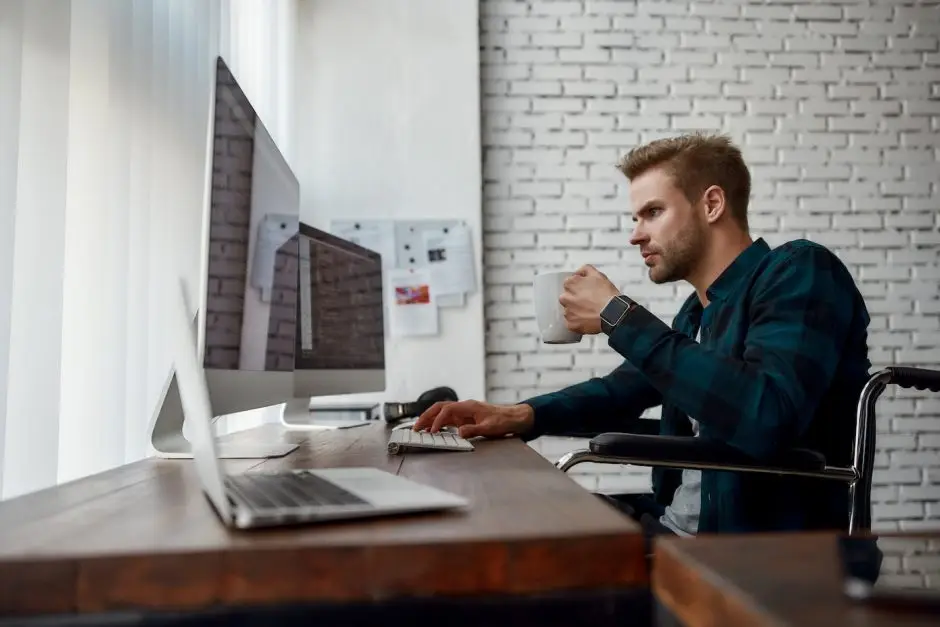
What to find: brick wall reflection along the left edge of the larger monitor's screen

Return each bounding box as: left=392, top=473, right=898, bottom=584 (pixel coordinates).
left=204, top=61, right=255, bottom=370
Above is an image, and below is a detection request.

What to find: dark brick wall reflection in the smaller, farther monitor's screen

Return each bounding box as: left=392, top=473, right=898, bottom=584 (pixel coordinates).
left=304, top=242, right=385, bottom=369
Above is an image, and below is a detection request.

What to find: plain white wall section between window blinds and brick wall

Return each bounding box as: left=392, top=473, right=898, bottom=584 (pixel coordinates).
left=294, top=0, right=485, bottom=408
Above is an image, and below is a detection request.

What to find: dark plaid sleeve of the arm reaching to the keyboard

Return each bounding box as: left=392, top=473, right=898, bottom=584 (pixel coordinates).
left=522, top=361, right=662, bottom=440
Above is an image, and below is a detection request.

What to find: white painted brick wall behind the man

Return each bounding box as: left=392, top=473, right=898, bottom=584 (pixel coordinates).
left=480, top=0, right=940, bottom=529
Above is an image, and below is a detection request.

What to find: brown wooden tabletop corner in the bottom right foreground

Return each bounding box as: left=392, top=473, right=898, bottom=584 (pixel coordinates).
left=652, top=533, right=940, bottom=627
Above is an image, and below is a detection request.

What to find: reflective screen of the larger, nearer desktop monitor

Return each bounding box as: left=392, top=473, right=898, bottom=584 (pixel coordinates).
left=203, top=59, right=300, bottom=372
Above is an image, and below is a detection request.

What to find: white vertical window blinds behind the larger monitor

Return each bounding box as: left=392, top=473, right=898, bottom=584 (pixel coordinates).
left=0, top=0, right=297, bottom=498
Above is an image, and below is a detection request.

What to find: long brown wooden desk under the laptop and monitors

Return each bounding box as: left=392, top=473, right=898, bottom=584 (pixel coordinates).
left=0, top=424, right=648, bottom=615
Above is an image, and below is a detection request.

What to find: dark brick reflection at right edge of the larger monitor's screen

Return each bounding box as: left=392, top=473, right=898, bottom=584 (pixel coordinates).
left=264, top=235, right=300, bottom=370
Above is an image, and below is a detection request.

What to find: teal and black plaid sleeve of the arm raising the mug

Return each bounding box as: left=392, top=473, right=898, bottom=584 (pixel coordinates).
left=608, top=247, right=855, bottom=459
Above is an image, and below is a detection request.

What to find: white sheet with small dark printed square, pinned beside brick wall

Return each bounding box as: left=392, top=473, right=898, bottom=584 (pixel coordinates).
left=422, top=225, right=476, bottom=296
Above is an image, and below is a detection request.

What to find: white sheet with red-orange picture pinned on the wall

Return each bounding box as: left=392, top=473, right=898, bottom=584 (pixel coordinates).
left=388, top=268, right=438, bottom=337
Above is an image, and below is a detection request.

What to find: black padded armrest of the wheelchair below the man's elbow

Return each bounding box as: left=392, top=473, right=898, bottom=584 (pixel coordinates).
left=590, top=433, right=826, bottom=471
